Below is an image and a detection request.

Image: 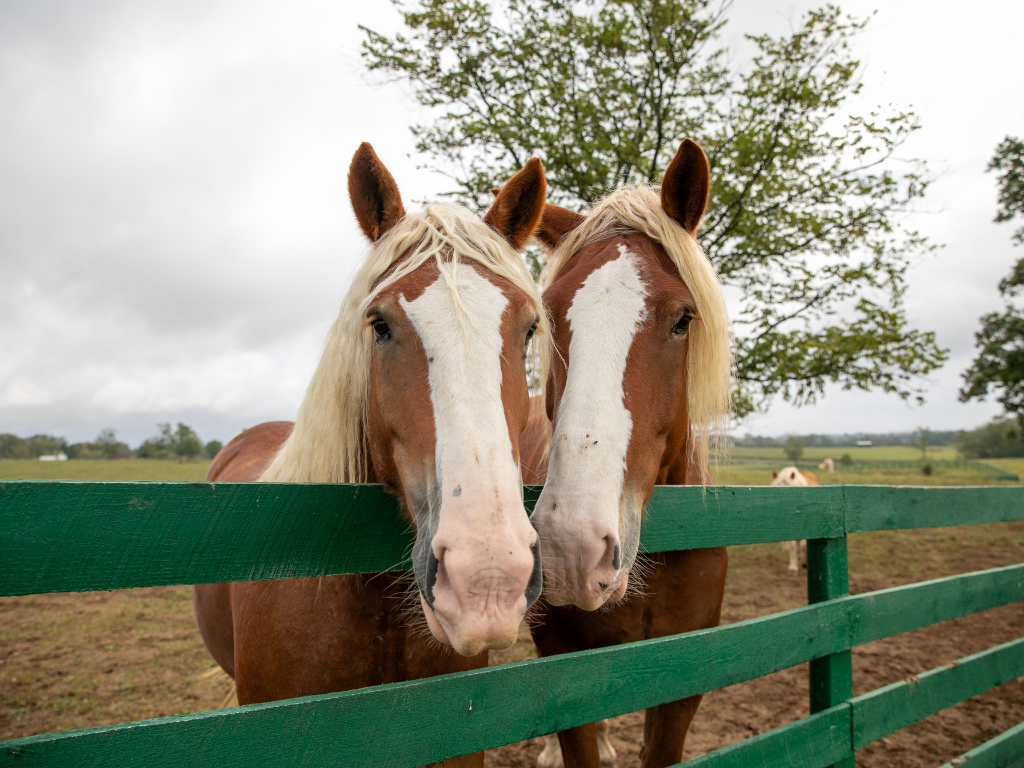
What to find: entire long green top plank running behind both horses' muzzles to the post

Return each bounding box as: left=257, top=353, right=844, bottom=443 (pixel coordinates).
left=0, top=480, right=843, bottom=595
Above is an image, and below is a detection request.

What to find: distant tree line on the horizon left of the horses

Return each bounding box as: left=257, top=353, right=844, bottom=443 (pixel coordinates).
left=0, top=422, right=223, bottom=461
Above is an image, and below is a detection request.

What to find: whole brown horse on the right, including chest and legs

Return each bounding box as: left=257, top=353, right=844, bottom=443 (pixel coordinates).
left=523, top=139, right=730, bottom=768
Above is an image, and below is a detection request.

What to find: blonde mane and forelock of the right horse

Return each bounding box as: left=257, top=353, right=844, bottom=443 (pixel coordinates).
left=541, top=185, right=732, bottom=458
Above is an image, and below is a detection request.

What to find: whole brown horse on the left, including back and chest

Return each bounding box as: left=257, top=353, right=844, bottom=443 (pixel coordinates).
left=195, top=144, right=547, bottom=766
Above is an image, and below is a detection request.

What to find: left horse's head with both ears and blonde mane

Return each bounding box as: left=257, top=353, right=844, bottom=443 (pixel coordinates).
left=264, top=143, right=547, bottom=655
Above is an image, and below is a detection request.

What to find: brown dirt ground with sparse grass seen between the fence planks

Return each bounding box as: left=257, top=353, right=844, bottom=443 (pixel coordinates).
left=0, top=523, right=1024, bottom=768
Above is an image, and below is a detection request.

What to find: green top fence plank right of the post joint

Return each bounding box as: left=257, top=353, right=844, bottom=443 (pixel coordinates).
left=843, top=485, right=1024, bottom=532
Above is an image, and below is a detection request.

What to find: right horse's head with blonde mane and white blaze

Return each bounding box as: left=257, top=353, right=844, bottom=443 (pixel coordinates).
left=532, top=139, right=730, bottom=610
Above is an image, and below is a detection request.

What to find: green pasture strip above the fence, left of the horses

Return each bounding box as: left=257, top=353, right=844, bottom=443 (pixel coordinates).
left=0, top=459, right=210, bottom=480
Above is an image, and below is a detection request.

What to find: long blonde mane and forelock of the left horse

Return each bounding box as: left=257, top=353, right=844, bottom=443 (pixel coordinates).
left=260, top=205, right=549, bottom=482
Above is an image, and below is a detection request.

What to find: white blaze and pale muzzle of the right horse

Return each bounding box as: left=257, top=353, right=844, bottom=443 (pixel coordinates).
left=535, top=240, right=647, bottom=586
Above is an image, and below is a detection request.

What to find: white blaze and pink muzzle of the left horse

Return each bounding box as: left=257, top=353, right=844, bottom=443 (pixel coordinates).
left=399, top=264, right=536, bottom=652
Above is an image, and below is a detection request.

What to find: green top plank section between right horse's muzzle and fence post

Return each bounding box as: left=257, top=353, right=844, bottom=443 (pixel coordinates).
left=640, top=485, right=843, bottom=552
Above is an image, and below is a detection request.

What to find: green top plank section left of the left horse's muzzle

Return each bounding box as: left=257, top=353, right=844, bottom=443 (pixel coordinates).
left=0, top=481, right=412, bottom=595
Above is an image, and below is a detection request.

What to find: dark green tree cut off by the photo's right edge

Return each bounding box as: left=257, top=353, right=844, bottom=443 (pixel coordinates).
left=959, top=136, right=1024, bottom=428
